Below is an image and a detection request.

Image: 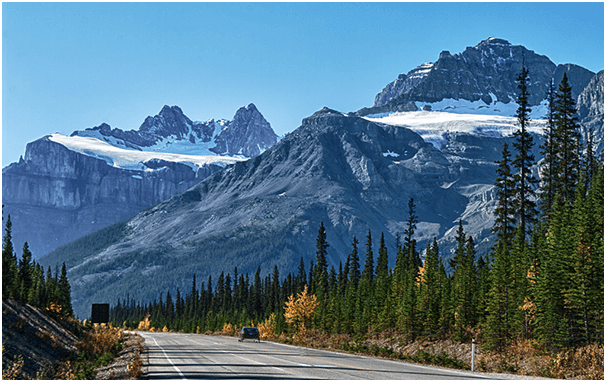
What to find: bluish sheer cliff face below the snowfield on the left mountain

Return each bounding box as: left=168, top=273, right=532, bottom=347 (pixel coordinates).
left=2, top=137, right=221, bottom=257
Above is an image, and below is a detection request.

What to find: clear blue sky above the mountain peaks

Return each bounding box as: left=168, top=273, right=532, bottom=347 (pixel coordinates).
left=2, top=2, right=604, bottom=166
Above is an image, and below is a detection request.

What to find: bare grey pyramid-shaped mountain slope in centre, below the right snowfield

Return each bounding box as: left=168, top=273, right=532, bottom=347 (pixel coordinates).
left=41, top=108, right=548, bottom=314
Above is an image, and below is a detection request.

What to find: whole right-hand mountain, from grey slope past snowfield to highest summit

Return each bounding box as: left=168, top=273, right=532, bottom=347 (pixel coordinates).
left=36, top=39, right=603, bottom=320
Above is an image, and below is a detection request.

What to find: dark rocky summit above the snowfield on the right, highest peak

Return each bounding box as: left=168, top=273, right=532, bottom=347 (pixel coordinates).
left=369, top=38, right=594, bottom=113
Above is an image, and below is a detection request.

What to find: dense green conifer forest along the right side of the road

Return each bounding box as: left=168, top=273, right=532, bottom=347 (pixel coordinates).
left=110, top=71, right=604, bottom=351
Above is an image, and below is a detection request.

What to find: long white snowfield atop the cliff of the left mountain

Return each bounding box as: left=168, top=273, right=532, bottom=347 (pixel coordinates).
left=49, top=134, right=244, bottom=171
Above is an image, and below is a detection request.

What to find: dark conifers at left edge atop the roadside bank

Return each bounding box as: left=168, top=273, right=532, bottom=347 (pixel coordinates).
left=2, top=215, right=73, bottom=316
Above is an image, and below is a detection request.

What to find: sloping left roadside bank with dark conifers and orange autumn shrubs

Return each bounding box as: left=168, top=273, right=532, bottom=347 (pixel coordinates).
left=2, top=216, right=142, bottom=380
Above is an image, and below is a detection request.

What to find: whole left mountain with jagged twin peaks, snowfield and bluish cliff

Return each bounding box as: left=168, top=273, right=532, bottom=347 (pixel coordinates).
left=2, top=104, right=277, bottom=258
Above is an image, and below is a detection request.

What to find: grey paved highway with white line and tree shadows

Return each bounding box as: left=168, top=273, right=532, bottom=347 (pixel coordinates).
left=138, top=332, right=509, bottom=380
